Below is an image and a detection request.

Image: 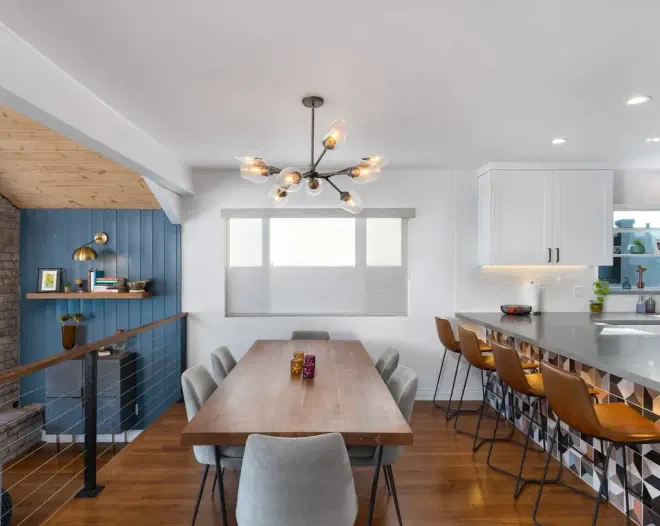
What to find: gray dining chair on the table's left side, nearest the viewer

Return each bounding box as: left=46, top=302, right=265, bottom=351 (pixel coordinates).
left=181, top=365, right=245, bottom=526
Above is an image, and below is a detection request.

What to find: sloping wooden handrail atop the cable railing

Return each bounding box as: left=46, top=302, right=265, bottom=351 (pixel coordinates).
left=0, top=312, right=188, bottom=385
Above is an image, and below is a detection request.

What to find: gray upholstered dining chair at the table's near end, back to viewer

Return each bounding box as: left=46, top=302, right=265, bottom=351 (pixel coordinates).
left=236, top=433, right=358, bottom=526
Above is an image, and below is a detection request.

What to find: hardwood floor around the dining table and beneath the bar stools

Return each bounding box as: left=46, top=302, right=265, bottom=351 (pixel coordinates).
left=48, top=402, right=625, bottom=526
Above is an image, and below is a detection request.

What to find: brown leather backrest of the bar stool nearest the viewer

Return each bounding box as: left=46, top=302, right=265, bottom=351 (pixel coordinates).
left=541, top=362, right=605, bottom=438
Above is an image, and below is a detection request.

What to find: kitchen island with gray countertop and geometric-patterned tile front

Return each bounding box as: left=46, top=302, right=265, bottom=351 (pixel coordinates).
left=456, top=312, right=660, bottom=526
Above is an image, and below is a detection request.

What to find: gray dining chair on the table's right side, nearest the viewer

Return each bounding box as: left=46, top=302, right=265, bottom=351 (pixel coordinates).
left=348, top=365, right=418, bottom=526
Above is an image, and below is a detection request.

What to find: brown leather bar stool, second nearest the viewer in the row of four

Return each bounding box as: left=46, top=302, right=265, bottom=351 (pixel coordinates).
left=487, top=343, right=598, bottom=499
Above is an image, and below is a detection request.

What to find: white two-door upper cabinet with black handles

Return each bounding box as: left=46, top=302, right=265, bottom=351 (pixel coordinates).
left=479, top=165, right=614, bottom=266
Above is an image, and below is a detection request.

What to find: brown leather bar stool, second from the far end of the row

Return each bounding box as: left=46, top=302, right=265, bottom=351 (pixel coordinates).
left=454, top=327, right=539, bottom=451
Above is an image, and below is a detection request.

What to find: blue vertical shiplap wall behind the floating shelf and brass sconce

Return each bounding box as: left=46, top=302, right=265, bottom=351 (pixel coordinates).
left=20, top=209, right=181, bottom=427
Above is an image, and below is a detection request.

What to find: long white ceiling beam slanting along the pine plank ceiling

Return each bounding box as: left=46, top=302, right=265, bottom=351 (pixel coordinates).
left=0, top=22, right=193, bottom=195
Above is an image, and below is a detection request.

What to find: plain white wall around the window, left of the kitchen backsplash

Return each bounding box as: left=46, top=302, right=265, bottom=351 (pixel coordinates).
left=182, top=170, right=480, bottom=398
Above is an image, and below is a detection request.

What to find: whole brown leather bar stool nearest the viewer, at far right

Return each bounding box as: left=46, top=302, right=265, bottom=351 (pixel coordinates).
left=532, top=363, right=660, bottom=525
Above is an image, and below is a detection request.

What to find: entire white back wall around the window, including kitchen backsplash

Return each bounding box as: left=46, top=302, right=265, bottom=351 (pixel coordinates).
left=182, top=170, right=660, bottom=399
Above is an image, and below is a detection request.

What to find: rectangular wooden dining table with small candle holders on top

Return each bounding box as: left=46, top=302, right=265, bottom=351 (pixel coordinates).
left=181, top=340, right=413, bottom=525
